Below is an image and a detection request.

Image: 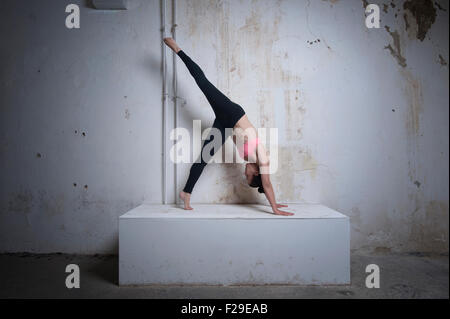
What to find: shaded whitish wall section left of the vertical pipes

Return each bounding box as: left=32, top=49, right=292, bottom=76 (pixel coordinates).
left=0, top=0, right=162, bottom=253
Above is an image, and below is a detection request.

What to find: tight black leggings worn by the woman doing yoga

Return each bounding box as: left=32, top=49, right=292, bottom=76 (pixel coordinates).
left=178, top=50, right=245, bottom=194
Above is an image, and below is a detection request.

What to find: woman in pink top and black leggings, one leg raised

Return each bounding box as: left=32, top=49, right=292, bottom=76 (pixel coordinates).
left=164, top=38, right=293, bottom=216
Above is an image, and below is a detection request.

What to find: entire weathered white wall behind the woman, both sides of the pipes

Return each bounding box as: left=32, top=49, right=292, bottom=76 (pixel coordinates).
left=0, top=0, right=449, bottom=253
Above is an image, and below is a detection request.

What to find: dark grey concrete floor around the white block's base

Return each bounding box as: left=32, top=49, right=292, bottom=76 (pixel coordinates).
left=0, top=253, right=449, bottom=299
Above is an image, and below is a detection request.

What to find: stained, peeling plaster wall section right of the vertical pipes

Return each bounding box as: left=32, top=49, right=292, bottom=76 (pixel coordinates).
left=174, top=0, right=449, bottom=255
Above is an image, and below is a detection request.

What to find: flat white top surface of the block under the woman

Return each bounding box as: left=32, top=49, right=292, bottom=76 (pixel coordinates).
left=120, top=204, right=348, bottom=219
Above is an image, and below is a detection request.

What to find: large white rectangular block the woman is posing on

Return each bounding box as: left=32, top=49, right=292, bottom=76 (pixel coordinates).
left=119, top=204, right=350, bottom=285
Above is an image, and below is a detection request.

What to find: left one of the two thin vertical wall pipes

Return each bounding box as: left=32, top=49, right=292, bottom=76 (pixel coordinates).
left=161, top=0, right=167, bottom=204
